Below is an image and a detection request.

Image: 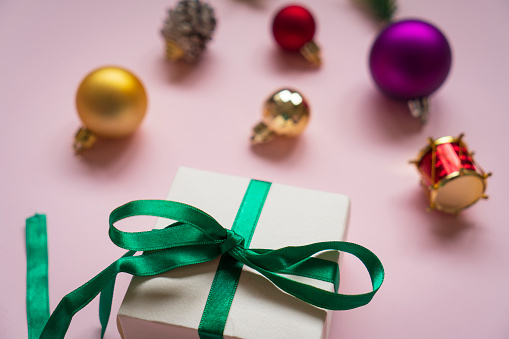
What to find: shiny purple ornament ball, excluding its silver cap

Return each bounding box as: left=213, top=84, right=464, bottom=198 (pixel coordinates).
left=369, top=20, right=452, bottom=100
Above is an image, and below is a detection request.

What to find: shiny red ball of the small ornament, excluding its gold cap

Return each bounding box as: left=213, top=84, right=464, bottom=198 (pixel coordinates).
left=272, top=5, right=316, bottom=51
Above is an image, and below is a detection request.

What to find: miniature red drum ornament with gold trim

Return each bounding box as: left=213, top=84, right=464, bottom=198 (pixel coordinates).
left=411, top=134, right=491, bottom=214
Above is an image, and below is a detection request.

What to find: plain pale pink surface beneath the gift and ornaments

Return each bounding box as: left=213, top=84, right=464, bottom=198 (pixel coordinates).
left=0, top=0, right=509, bottom=339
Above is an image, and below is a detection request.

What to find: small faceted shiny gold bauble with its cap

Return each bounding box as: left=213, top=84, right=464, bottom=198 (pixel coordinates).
left=251, top=88, right=309, bottom=144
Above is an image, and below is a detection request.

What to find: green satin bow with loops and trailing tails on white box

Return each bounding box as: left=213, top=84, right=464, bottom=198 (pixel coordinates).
left=26, top=193, right=384, bottom=339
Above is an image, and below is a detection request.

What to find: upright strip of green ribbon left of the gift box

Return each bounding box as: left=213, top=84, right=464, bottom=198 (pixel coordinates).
left=26, top=214, right=49, bottom=339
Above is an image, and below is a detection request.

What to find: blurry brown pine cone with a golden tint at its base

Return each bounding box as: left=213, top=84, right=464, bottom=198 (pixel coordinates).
left=161, top=0, right=216, bottom=62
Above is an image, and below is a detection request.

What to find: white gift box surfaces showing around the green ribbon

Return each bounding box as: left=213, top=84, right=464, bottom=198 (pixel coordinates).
left=117, top=168, right=350, bottom=339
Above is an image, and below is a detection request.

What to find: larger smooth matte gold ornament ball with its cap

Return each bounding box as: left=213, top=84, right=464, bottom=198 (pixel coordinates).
left=74, top=67, right=147, bottom=152
